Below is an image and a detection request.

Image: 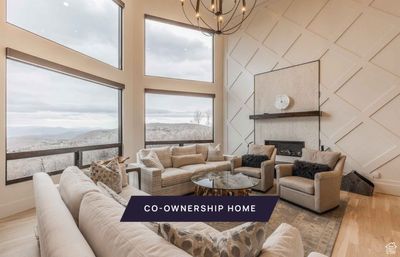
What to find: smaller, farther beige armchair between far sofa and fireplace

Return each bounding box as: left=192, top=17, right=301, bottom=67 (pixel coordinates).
left=232, top=145, right=276, bottom=192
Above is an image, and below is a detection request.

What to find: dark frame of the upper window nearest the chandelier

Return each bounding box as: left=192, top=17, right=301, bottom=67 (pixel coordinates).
left=143, top=14, right=215, bottom=84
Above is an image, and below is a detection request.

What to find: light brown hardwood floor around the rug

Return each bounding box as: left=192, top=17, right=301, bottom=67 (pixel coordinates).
left=0, top=192, right=400, bottom=257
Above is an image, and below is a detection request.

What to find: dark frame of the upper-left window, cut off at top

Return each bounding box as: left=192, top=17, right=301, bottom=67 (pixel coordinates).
left=5, top=0, right=125, bottom=70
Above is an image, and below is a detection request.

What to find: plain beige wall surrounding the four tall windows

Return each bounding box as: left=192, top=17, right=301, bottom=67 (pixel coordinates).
left=0, top=0, right=223, bottom=218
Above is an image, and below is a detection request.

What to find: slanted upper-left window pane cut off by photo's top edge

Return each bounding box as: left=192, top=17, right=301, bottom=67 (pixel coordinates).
left=7, top=0, right=123, bottom=68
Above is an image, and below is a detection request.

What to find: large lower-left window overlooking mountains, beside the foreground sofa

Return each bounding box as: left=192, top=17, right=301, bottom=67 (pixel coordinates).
left=6, top=49, right=123, bottom=183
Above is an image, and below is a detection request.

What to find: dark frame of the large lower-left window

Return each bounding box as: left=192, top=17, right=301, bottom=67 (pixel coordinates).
left=5, top=48, right=125, bottom=186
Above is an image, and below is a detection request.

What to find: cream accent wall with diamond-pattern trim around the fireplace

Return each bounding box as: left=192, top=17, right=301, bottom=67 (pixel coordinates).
left=225, top=0, right=400, bottom=195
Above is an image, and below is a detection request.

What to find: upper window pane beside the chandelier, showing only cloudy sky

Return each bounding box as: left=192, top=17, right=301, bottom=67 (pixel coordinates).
left=145, top=16, right=214, bottom=82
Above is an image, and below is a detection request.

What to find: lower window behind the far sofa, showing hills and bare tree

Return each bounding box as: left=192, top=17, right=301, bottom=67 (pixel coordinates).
left=145, top=90, right=214, bottom=147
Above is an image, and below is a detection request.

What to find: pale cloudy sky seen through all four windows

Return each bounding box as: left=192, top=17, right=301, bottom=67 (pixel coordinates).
left=7, top=0, right=213, bottom=137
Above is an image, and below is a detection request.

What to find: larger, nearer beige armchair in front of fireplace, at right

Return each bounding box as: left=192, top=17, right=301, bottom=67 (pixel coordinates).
left=276, top=149, right=346, bottom=213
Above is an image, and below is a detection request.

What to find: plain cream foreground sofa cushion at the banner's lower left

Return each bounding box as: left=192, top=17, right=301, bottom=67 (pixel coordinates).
left=79, top=192, right=191, bottom=257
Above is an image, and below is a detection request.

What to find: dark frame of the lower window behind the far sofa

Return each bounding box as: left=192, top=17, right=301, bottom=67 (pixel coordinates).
left=144, top=88, right=215, bottom=148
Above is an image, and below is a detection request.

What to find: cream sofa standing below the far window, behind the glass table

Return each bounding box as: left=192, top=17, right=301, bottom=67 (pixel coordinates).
left=137, top=144, right=235, bottom=195
